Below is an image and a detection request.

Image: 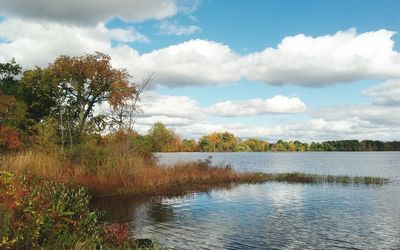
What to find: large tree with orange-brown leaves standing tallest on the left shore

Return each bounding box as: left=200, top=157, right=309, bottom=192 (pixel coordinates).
left=50, top=52, right=135, bottom=138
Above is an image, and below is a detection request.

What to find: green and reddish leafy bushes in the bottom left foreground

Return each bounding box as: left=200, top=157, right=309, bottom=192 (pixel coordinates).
left=0, top=171, right=138, bottom=249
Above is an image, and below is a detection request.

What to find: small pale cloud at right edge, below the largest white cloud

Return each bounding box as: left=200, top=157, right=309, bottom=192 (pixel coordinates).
left=362, top=79, right=400, bottom=106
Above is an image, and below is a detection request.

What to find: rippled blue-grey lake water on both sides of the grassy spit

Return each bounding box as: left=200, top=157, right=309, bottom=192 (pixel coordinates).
left=92, top=152, right=400, bottom=249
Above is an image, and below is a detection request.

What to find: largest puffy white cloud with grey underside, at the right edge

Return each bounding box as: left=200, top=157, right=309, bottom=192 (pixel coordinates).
left=242, top=29, right=400, bottom=86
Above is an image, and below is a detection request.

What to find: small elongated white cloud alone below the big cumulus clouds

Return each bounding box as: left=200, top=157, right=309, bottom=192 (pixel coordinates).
left=208, top=95, right=307, bottom=116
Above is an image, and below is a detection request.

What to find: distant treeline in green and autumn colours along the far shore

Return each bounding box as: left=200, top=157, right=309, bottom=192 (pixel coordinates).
left=141, top=123, right=400, bottom=152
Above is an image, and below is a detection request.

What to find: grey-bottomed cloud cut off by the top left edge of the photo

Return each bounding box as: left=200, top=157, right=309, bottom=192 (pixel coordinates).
left=0, top=0, right=180, bottom=25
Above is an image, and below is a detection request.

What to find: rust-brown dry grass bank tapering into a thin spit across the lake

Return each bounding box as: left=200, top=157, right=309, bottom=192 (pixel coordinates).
left=0, top=151, right=388, bottom=194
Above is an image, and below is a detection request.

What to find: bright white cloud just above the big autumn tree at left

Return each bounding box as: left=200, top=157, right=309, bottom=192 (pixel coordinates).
left=0, top=18, right=147, bottom=68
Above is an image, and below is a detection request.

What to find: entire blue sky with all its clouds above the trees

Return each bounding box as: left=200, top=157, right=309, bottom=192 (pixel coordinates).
left=0, top=0, right=400, bottom=142
